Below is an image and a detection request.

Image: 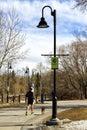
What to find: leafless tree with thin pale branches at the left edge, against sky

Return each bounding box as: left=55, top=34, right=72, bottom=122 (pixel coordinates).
left=0, top=9, right=25, bottom=68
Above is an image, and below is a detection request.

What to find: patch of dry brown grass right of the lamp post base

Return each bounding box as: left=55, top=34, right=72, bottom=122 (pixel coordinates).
left=58, top=108, right=87, bottom=121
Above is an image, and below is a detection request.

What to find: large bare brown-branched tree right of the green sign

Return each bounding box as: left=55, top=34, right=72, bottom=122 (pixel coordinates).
left=58, top=41, right=87, bottom=98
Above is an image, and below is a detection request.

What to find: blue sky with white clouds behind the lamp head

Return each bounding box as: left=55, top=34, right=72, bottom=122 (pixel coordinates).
left=0, top=0, right=87, bottom=74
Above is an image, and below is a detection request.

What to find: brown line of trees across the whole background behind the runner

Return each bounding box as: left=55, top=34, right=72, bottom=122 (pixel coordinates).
left=0, top=40, right=87, bottom=100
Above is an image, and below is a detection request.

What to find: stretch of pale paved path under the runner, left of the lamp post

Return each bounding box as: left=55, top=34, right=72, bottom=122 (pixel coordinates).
left=0, top=102, right=52, bottom=130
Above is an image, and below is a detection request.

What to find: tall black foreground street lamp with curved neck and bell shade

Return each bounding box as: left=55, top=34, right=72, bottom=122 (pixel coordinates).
left=37, top=5, right=59, bottom=125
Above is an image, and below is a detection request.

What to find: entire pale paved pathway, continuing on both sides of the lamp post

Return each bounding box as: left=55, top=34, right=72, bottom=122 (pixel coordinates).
left=0, top=100, right=87, bottom=130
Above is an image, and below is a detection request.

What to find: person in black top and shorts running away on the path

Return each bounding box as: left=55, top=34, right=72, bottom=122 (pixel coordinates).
left=26, top=87, right=34, bottom=115
